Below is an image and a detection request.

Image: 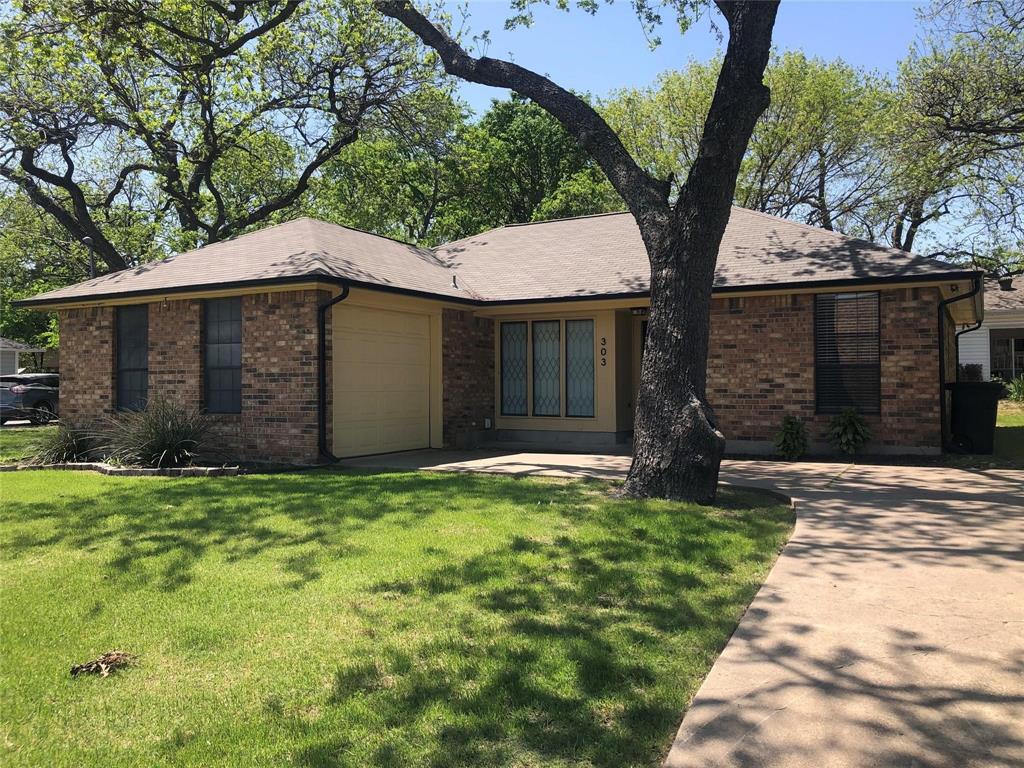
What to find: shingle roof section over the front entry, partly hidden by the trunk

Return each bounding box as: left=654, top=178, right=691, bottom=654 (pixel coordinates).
left=435, top=207, right=963, bottom=301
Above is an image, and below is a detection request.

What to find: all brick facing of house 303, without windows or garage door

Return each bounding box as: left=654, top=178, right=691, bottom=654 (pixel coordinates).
left=59, top=288, right=942, bottom=464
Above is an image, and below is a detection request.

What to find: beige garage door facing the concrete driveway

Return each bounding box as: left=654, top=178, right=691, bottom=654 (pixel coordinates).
left=333, top=304, right=430, bottom=457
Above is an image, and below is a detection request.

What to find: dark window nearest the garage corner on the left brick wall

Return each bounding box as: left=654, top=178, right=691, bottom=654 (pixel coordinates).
left=203, top=297, right=242, bottom=414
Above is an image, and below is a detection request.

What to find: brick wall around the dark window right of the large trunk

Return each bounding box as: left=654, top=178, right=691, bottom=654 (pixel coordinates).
left=708, top=288, right=940, bottom=449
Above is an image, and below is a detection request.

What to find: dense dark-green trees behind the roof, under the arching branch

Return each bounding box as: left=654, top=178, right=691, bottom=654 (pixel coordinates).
left=306, top=92, right=624, bottom=245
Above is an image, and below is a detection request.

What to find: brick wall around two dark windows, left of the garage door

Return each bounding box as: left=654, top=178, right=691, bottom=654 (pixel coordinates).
left=59, top=291, right=330, bottom=464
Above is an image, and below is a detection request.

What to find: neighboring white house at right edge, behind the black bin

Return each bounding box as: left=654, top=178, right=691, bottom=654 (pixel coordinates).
left=959, top=278, right=1024, bottom=381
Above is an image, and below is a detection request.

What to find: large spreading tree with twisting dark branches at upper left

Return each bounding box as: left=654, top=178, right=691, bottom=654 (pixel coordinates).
left=0, top=0, right=436, bottom=269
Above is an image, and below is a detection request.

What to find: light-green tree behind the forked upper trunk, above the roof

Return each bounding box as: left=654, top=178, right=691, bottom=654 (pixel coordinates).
left=602, top=52, right=885, bottom=229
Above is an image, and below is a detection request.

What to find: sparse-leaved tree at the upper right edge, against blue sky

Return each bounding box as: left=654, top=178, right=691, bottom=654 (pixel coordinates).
left=900, top=0, right=1024, bottom=274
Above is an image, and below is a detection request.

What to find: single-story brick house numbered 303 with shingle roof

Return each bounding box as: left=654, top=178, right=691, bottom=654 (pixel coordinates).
left=23, top=208, right=982, bottom=463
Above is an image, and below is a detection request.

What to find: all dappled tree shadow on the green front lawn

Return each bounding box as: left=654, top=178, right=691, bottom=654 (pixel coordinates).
left=4, top=472, right=792, bottom=768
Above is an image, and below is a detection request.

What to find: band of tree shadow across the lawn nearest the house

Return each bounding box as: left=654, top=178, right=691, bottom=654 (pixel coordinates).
left=3, top=471, right=592, bottom=592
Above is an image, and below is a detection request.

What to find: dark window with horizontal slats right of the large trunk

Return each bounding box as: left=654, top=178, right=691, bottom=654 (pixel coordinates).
left=814, top=293, right=882, bottom=414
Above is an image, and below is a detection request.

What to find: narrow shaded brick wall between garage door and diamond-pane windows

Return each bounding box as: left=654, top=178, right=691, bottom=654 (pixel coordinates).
left=441, top=309, right=495, bottom=447
